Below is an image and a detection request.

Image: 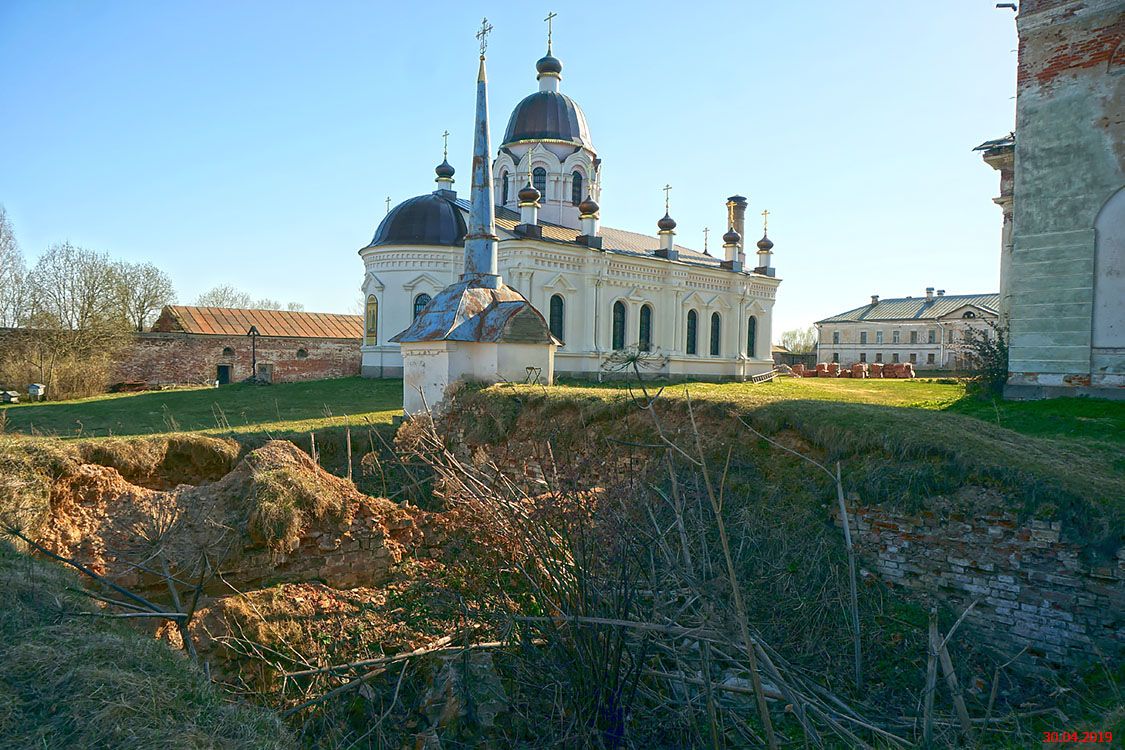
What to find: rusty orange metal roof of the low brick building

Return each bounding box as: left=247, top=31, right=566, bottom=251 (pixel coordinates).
left=152, top=305, right=363, bottom=338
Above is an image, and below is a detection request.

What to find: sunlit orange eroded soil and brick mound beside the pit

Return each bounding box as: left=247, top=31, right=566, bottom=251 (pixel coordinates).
left=24, top=441, right=428, bottom=588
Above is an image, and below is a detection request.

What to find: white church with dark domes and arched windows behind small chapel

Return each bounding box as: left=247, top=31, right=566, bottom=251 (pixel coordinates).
left=359, top=31, right=781, bottom=380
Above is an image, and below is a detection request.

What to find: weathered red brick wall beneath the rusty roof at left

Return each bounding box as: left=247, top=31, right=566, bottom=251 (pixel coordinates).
left=113, top=333, right=360, bottom=385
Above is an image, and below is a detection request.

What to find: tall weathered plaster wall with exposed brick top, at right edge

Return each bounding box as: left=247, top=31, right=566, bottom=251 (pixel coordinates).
left=1006, top=0, right=1125, bottom=397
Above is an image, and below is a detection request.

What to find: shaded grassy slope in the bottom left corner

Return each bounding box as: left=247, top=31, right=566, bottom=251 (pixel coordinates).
left=0, top=542, right=294, bottom=750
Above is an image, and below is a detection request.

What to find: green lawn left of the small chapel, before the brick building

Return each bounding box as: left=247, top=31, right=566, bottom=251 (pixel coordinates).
left=0, top=378, right=403, bottom=437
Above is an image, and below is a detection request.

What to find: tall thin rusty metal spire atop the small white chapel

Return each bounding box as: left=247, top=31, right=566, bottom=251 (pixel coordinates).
left=461, top=18, right=501, bottom=289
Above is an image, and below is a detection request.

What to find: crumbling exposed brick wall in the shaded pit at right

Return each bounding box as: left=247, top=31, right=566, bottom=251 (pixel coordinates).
left=837, top=490, right=1125, bottom=667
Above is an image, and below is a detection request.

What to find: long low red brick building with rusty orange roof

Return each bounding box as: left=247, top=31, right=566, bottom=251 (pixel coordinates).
left=114, top=305, right=363, bottom=386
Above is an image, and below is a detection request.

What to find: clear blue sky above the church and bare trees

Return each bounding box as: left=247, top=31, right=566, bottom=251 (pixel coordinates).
left=0, top=0, right=1016, bottom=336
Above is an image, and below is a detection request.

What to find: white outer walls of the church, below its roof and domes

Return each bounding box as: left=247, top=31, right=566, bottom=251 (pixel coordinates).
left=362, top=240, right=779, bottom=380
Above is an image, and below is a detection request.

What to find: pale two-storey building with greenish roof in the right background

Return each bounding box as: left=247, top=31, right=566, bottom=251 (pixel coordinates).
left=816, top=287, right=1000, bottom=370
